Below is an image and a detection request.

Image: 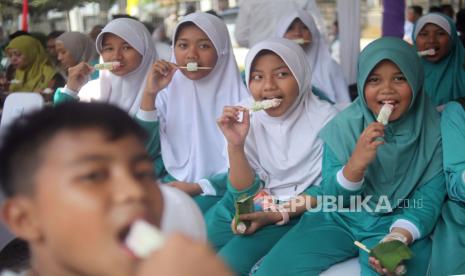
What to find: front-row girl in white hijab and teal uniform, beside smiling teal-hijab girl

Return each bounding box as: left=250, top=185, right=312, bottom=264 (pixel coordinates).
left=207, top=38, right=337, bottom=275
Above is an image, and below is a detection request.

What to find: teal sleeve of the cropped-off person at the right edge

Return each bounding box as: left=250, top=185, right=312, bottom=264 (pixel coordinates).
left=441, top=102, right=465, bottom=202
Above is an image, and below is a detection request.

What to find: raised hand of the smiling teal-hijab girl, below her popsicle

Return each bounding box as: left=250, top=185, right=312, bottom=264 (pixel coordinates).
left=349, top=122, right=384, bottom=171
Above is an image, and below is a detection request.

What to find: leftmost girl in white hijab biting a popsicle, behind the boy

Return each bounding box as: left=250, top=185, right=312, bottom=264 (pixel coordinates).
left=54, top=18, right=157, bottom=116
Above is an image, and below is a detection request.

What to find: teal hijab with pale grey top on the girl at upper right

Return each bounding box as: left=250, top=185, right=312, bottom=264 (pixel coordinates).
left=413, top=13, right=465, bottom=105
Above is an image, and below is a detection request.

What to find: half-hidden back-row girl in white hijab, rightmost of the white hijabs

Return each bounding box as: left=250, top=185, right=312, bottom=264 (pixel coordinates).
left=276, top=9, right=350, bottom=104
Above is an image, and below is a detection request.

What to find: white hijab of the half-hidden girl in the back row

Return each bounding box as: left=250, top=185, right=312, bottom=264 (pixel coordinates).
left=276, top=9, right=350, bottom=103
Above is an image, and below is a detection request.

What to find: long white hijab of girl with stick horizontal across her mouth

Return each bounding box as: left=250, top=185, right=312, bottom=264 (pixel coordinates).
left=156, top=13, right=249, bottom=182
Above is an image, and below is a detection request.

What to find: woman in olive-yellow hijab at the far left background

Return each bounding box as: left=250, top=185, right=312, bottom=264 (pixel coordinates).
left=6, top=35, right=64, bottom=92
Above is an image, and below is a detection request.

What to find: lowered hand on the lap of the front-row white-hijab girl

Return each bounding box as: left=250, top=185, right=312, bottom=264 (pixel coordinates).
left=231, top=212, right=283, bottom=235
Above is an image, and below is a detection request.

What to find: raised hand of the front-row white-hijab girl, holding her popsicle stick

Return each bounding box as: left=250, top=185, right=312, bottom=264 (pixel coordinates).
left=217, top=106, right=250, bottom=147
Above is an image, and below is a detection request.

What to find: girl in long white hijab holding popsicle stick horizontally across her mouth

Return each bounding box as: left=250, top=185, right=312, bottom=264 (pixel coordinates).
left=141, top=13, right=248, bottom=212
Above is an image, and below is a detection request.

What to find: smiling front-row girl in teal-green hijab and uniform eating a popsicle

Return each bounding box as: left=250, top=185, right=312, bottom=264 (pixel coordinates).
left=257, top=37, right=445, bottom=275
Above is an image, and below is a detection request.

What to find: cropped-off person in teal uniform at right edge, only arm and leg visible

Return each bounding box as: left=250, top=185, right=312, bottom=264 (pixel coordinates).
left=430, top=98, right=465, bottom=276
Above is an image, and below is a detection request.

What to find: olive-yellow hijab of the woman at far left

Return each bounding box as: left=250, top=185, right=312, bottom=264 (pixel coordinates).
left=6, top=35, right=57, bottom=92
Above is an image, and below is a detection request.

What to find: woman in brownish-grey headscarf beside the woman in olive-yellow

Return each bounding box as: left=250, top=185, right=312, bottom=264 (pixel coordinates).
left=55, top=32, right=99, bottom=79
